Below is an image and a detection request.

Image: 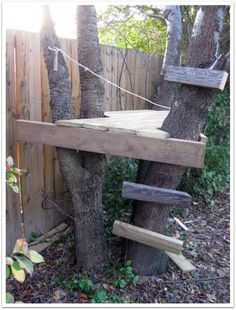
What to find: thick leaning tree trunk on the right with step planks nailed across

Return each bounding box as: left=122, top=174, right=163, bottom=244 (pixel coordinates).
left=128, top=6, right=229, bottom=274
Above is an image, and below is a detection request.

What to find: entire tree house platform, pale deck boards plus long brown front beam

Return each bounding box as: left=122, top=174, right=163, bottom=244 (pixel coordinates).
left=16, top=110, right=206, bottom=168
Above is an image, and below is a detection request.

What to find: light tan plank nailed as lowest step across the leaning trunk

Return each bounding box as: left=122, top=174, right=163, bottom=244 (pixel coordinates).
left=112, top=221, right=183, bottom=254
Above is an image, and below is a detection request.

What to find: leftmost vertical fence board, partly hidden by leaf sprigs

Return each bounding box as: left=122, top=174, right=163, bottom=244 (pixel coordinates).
left=6, top=30, right=22, bottom=254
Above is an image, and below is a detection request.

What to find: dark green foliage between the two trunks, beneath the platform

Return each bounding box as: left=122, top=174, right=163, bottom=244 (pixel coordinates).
left=103, top=156, right=138, bottom=233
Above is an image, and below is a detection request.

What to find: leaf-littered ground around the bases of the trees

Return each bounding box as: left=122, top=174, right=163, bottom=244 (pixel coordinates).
left=7, top=194, right=230, bottom=304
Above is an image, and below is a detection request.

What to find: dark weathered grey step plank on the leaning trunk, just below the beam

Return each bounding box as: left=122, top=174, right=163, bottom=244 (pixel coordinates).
left=122, top=182, right=192, bottom=207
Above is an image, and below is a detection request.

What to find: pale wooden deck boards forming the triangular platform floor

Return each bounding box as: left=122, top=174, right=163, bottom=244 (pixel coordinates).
left=56, top=110, right=169, bottom=139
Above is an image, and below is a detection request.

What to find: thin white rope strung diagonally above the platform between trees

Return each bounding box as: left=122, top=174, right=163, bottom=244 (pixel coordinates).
left=48, top=46, right=171, bottom=110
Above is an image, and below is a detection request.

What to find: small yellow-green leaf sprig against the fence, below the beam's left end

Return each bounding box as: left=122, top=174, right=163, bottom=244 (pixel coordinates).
left=6, top=156, right=27, bottom=194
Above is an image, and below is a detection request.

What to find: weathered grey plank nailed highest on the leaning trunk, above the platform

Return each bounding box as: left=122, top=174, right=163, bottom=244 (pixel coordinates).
left=164, top=66, right=228, bottom=90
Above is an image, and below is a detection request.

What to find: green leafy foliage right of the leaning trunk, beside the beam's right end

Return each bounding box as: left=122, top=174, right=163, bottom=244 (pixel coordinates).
left=181, top=89, right=230, bottom=205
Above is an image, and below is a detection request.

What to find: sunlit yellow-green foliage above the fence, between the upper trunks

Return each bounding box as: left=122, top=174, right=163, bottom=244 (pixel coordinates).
left=98, top=5, right=166, bottom=55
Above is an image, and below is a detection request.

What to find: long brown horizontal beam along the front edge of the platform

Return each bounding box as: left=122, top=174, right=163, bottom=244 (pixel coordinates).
left=16, top=120, right=205, bottom=168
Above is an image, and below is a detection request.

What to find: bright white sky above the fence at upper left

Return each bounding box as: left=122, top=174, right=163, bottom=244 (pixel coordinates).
left=3, top=2, right=107, bottom=38
